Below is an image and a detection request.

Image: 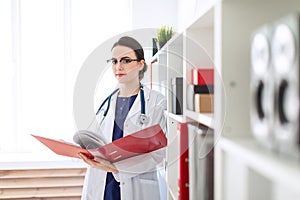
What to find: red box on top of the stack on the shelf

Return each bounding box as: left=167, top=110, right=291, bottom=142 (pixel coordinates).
left=192, top=68, right=214, bottom=85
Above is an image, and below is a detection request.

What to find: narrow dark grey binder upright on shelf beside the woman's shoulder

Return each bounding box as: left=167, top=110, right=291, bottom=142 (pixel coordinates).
left=171, top=77, right=183, bottom=115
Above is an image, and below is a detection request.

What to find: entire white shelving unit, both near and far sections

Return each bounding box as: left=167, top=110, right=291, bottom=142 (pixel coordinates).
left=153, top=0, right=300, bottom=200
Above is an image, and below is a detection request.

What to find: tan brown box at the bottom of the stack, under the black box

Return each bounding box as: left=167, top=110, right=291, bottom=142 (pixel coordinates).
left=195, top=94, right=214, bottom=113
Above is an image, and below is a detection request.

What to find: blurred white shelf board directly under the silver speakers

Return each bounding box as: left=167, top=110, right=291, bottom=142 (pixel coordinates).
left=216, top=137, right=300, bottom=191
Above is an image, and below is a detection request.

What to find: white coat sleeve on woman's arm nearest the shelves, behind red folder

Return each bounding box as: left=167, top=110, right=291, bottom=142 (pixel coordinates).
left=113, top=98, right=166, bottom=181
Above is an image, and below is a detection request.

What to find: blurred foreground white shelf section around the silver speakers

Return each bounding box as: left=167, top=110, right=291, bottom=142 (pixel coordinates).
left=214, top=0, right=300, bottom=200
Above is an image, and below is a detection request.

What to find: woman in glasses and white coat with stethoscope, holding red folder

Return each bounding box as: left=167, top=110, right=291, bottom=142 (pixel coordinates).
left=80, top=36, right=166, bottom=200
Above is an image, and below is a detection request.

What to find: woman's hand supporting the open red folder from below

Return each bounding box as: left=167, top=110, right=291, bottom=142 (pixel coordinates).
left=78, top=153, right=119, bottom=173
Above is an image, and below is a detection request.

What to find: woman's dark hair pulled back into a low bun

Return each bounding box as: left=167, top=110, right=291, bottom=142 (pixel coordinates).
left=111, top=36, right=147, bottom=80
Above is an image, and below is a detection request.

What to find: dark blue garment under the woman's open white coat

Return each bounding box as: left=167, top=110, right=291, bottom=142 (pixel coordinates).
left=104, top=95, right=137, bottom=200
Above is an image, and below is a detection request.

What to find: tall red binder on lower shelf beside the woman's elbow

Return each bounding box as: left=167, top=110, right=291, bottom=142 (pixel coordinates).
left=178, top=123, right=189, bottom=200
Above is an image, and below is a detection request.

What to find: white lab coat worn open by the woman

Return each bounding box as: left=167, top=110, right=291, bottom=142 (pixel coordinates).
left=82, top=86, right=167, bottom=200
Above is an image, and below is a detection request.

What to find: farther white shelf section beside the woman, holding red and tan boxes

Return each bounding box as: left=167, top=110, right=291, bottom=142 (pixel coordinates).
left=151, top=1, right=214, bottom=199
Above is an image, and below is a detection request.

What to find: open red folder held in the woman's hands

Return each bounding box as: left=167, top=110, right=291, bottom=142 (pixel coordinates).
left=32, top=124, right=167, bottom=163
